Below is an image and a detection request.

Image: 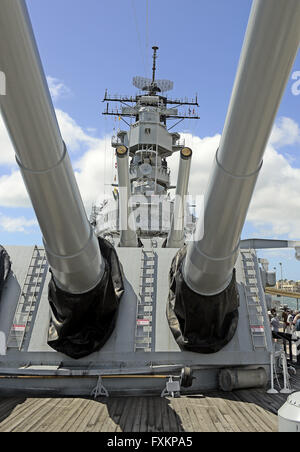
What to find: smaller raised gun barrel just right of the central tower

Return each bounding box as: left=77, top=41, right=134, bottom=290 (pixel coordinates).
left=166, top=147, right=193, bottom=248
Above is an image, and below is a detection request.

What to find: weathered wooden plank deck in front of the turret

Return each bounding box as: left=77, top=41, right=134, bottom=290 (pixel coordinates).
left=0, top=370, right=300, bottom=432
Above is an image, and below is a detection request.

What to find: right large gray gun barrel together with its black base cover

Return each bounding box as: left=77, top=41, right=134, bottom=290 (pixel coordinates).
left=167, top=0, right=300, bottom=353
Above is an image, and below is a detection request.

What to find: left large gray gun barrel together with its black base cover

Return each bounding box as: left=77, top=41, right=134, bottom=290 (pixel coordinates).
left=0, top=0, right=123, bottom=358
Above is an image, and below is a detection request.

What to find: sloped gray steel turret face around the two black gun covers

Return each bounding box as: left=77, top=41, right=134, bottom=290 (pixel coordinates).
left=0, top=246, right=272, bottom=395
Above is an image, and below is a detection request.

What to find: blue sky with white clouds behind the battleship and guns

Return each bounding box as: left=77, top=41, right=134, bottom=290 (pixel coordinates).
left=0, top=0, right=300, bottom=279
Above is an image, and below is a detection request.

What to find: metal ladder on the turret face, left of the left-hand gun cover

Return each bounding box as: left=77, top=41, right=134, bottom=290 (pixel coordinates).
left=7, top=246, right=48, bottom=350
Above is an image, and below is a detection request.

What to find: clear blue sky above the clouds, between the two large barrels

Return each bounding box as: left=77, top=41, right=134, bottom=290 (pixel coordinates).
left=27, top=0, right=251, bottom=135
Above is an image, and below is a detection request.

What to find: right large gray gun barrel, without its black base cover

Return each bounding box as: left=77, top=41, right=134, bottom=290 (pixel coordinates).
left=183, top=0, right=300, bottom=295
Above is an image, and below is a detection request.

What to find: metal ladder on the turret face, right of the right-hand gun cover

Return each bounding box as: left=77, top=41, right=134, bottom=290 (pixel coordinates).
left=241, top=250, right=267, bottom=350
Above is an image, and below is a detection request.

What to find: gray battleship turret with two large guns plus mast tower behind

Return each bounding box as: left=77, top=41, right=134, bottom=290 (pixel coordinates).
left=0, top=0, right=300, bottom=396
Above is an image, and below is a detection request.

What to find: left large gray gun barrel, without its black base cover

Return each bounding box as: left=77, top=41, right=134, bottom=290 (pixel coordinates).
left=0, top=0, right=104, bottom=294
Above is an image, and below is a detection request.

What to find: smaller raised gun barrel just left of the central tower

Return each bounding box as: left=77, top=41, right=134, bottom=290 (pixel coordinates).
left=116, top=146, right=138, bottom=248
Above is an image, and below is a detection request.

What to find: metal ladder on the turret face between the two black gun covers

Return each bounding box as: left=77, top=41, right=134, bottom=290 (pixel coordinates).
left=134, top=250, right=157, bottom=352
